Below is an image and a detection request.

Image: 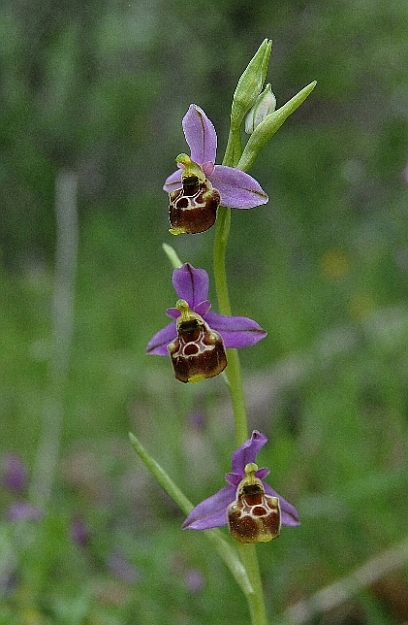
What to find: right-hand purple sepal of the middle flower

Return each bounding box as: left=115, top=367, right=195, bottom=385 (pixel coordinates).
left=205, top=312, right=267, bottom=349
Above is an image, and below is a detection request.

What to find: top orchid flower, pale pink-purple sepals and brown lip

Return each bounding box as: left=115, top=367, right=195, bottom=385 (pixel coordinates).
left=163, top=104, right=268, bottom=234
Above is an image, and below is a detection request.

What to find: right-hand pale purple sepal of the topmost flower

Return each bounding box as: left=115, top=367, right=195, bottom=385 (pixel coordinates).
left=210, top=165, right=269, bottom=208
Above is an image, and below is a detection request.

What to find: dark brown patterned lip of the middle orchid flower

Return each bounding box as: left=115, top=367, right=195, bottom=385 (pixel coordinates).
left=168, top=315, right=227, bottom=382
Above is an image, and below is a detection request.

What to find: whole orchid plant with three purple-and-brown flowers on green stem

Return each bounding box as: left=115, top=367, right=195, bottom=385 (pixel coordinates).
left=130, top=40, right=316, bottom=625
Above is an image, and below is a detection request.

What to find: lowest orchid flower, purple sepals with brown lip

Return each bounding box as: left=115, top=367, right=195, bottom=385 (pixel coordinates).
left=182, top=430, right=299, bottom=543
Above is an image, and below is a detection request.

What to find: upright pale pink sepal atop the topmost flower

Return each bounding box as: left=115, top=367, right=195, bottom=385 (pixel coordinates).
left=182, top=104, right=217, bottom=165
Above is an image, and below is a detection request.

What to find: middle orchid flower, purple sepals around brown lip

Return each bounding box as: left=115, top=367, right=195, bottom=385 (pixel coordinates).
left=147, top=263, right=266, bottom=382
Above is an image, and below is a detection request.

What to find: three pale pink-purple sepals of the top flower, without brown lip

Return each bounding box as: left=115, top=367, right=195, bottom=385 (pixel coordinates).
left=163, top=104, right=269, bottom=209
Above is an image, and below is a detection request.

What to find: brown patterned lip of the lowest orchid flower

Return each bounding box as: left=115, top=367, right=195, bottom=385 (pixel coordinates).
left=227, top=478, right=281, bottom=543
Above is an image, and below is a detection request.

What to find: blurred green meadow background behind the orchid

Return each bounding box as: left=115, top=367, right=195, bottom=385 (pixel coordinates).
left=0, top=0, right=408, bottom=625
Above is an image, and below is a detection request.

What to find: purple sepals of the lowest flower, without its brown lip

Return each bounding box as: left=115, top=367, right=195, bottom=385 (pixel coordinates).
left=182, top=430, right=300, bottom=530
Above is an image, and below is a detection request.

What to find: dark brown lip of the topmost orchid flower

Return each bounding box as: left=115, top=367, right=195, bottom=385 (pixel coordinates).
left=169, top=175, right=221, bottom=234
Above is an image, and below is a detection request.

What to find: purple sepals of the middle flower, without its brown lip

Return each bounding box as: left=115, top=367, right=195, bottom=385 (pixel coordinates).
left=147, top=263, right=267, bottom=356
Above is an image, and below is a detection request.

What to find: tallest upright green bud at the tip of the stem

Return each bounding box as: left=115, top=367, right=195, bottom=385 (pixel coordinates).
left=231, top=39, right=272, bottom=128
